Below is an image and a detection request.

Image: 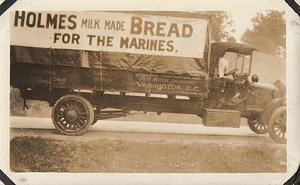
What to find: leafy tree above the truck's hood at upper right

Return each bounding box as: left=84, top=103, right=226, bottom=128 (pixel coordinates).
left=241, top=10, right=285, bottom=55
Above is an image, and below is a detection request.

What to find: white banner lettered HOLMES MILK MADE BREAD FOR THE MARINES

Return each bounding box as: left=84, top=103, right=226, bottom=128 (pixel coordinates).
left=11, top=11, right=208, bottom=58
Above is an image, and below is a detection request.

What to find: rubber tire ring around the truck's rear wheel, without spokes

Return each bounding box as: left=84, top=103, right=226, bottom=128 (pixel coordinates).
left=51, top=94, right=94, bottom=136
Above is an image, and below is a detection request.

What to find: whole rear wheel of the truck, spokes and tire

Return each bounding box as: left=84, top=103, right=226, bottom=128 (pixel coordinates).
left=52, top=95, right=94, bottom=135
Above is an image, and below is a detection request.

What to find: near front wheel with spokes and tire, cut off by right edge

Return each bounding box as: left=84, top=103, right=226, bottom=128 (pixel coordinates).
left=268, top=107, right=286, bottom=143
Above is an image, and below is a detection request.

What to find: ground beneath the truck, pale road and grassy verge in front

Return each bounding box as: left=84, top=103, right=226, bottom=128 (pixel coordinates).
left=10, top=117, right=286, bottom=173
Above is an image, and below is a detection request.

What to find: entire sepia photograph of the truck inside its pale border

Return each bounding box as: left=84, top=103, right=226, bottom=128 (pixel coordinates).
left=9, top=9, right=287, bottom=173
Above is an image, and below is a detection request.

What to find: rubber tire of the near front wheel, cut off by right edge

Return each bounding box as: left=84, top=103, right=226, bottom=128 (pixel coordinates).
left=268, top=106, right=286, bottom=144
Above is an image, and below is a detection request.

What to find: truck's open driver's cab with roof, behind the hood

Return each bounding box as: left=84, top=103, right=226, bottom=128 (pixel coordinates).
left=208, top=42, right=258, bottom=109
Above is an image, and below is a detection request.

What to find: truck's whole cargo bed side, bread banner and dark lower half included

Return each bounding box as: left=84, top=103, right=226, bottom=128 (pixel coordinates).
left=11, top=11, right=210, bottom=96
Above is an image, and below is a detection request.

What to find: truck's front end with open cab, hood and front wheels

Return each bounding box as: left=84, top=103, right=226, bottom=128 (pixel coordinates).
left=207, top=42, right=286, bottom=142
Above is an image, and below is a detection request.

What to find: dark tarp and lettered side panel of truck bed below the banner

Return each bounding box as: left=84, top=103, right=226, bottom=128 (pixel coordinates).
left=11, top=46, right=207, bottom=96
